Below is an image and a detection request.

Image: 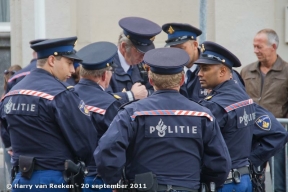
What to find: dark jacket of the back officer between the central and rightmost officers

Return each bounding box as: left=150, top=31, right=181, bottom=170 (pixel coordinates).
left=180, top=66, right=245, bottom=102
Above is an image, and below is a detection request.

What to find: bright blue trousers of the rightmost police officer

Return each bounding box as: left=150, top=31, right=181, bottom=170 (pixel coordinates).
left=217, top=175, right=252, bottom=192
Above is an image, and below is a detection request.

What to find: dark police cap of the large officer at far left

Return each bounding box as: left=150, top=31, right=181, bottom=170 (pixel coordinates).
left=31, top=37, right=81, bottom=61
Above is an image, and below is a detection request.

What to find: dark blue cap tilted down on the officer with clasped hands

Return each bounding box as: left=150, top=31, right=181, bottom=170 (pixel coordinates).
left=119, top=17, right=161, bottom=53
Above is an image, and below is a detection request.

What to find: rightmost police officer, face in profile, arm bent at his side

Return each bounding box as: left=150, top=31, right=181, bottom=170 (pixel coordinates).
left=195, top=41, right=287, bottom=192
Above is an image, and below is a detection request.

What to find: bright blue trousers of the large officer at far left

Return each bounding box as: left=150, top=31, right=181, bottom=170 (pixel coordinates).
left=11, top=170, right=71, bottom=192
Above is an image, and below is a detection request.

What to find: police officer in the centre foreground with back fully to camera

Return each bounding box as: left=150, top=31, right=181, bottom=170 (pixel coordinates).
left=94, top=48, right=231, bottom=192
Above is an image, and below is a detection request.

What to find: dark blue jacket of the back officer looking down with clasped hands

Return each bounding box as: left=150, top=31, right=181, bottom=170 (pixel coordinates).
left=106, top=53, right=153, bottom=102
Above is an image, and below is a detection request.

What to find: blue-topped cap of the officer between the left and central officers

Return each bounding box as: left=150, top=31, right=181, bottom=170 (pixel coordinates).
left=76, top=41, right=118, bottom=70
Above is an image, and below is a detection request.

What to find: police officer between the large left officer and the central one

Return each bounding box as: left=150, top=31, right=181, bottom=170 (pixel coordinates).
left=75, top=42, right=122, bottom=192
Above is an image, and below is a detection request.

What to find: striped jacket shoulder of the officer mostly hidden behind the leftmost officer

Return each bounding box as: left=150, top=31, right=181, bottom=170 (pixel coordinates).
left=5, top=59, right=37, bottom=93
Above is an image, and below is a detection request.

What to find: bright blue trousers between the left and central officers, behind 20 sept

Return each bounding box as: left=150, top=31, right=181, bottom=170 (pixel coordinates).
left=82, top=176, right=112, bottom=192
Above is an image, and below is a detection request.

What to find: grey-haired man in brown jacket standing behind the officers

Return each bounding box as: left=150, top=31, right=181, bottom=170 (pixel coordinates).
left=241, top=29, right=288, bottom=191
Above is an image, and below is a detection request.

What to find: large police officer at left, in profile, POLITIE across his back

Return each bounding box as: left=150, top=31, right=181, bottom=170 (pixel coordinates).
left=1, top=37, right=97, bottom=192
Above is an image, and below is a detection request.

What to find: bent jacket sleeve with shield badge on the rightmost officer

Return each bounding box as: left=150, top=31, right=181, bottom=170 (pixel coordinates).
left=249, top=103, right=288, bottom=167
